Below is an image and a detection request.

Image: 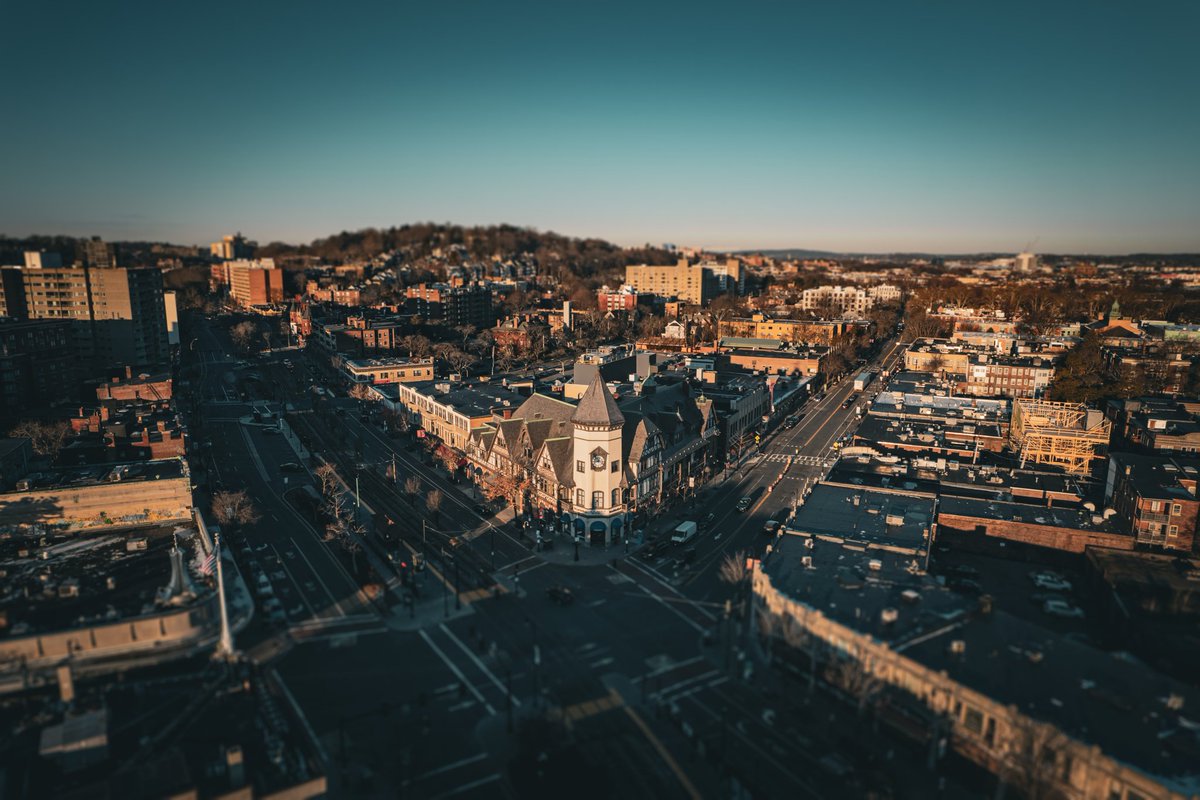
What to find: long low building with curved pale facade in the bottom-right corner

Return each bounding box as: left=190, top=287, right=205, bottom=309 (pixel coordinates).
left=751, top=535, right=1200, bottom=800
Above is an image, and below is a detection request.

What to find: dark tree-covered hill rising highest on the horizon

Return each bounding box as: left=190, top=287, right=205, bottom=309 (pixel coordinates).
left=258, top=223, right=676, bottom=278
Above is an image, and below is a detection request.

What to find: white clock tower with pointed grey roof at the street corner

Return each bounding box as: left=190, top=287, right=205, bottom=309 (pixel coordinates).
left=571, top=372, right=625, bottom=545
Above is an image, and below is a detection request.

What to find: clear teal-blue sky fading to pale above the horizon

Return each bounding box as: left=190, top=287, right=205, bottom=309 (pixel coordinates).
left=0, top=0, right=1200, bottom=253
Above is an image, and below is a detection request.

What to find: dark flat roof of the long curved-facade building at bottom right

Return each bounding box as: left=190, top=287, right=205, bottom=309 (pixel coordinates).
left=763, top=536, right=1200, bottom=795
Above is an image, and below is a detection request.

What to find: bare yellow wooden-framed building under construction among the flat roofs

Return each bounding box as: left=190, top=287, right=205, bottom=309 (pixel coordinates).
left=1009, top=399, right=1112, bottom=475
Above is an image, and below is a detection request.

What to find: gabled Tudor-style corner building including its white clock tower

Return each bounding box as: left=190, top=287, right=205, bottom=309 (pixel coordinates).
left=467, top=374, right=718, bottom=545
